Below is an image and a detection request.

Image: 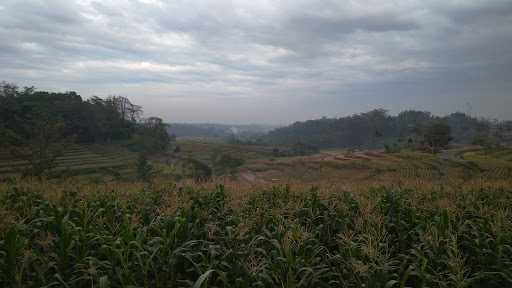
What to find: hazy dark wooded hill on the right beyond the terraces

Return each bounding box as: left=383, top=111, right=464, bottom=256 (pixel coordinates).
left=264, top=109, right=491, bottom=148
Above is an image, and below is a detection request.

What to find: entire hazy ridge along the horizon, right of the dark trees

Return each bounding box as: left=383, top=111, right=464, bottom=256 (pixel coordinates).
left=167, top=109, right=512, bottom=148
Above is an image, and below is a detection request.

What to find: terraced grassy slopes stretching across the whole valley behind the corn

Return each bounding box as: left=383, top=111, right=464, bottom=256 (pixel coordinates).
left=0, top=140, right=512, bottom=186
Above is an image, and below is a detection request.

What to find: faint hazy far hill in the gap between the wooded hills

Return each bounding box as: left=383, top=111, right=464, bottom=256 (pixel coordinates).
left=167, top=123, right=277, bottom=139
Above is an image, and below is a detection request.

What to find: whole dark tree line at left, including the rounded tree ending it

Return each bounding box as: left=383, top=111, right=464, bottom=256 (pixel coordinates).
left=0, top=82, right=170, bottom=175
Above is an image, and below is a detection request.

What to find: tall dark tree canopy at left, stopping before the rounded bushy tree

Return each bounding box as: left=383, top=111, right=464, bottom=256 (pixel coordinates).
left=0, top=83, right=142, bottom=143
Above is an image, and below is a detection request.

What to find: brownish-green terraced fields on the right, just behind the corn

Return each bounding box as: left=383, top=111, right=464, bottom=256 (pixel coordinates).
left=241, top=147, right=512, bottom=187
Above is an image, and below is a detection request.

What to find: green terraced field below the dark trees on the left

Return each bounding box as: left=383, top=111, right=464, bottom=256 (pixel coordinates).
left=0, top=145, right=136, bottom=178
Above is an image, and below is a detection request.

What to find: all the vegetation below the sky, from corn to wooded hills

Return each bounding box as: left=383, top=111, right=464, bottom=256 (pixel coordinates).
left=0, top=84, right=512, bottom=288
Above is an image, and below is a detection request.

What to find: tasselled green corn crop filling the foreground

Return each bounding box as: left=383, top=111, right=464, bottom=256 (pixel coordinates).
left=0, top=183, right=512, bottom=287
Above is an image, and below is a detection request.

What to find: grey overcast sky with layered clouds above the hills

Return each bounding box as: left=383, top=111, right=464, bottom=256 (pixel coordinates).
left=0, top=0, right=512, bottom=123
